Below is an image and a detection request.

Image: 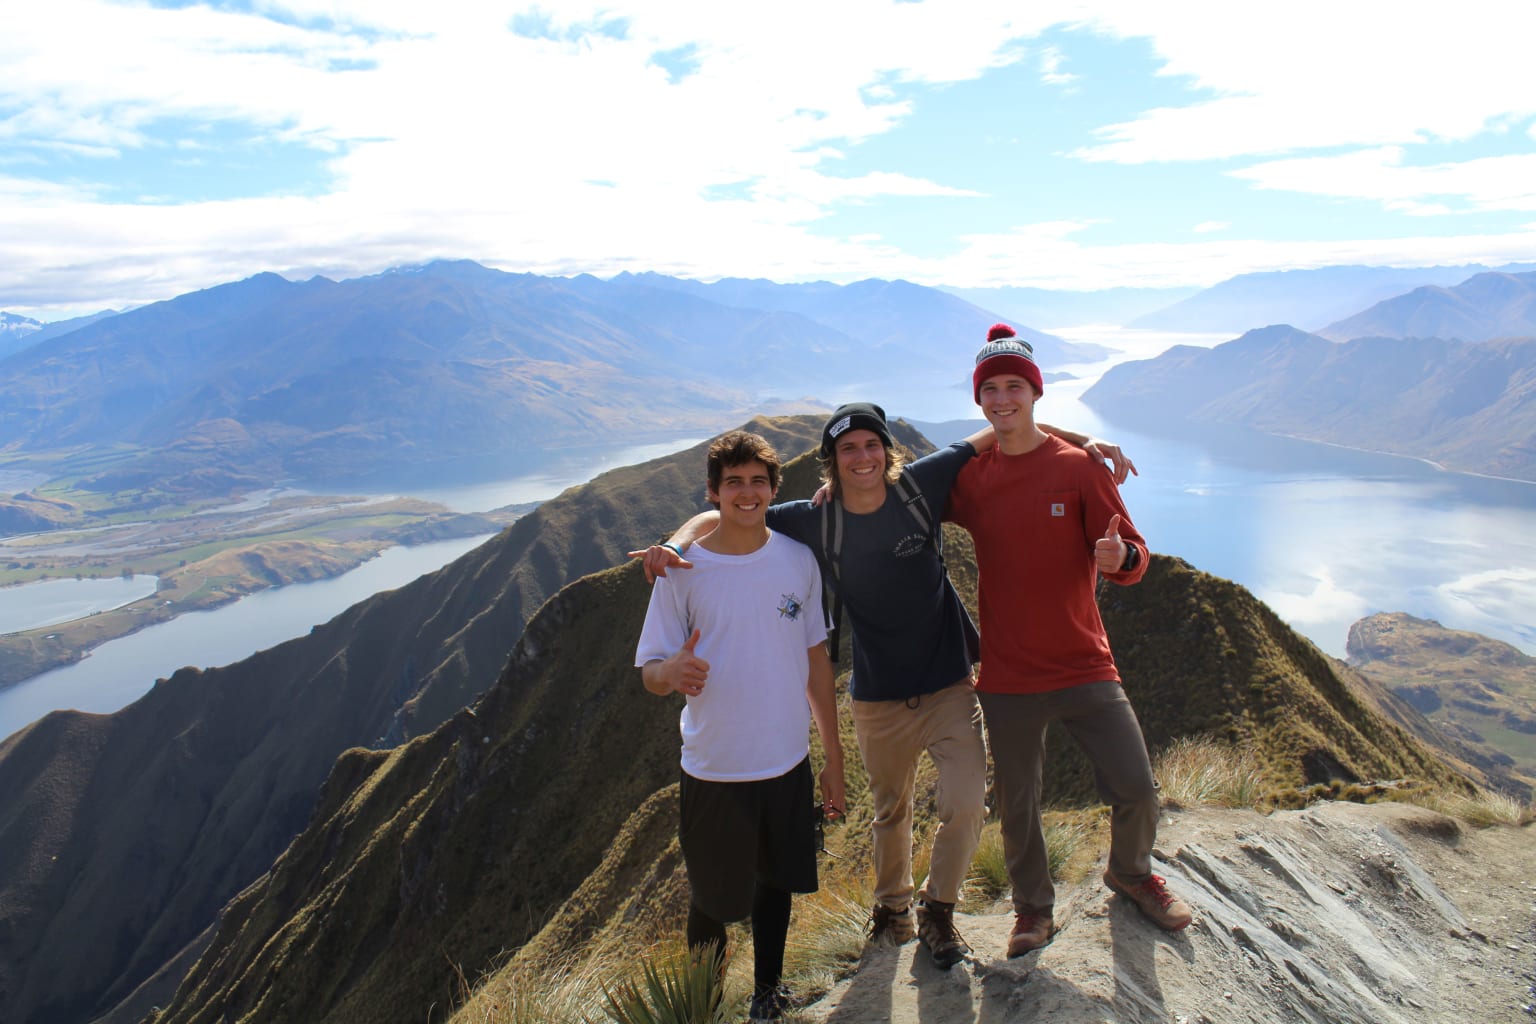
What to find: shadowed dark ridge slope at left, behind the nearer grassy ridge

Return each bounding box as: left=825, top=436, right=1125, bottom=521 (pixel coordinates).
left=0, top=416, right=820, bottom=1024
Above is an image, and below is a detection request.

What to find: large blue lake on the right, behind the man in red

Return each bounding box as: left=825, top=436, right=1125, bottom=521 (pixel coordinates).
left=854, top=327, right=1536, bottom=657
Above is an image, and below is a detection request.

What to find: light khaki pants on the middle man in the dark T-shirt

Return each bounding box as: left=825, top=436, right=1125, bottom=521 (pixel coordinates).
left=852, top=680, right=986, bottom=910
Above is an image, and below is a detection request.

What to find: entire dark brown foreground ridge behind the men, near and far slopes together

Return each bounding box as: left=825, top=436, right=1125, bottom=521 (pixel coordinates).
left=0, top=416, right=1490, bottom=1024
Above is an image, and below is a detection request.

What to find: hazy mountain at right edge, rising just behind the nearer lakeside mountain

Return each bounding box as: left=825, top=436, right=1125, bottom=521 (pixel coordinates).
left=1318, top=273, right=1536, bottom=341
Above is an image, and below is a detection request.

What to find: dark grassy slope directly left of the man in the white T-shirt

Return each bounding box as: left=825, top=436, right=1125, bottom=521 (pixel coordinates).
left=157, top=565, right=677, bottom=1024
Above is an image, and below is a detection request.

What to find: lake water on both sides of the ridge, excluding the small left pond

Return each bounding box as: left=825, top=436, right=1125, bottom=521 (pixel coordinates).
left=0, top=329, right=1536, bottom=735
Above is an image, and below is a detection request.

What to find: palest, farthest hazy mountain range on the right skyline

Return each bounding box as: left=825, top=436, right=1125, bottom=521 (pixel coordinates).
left=1127, top=264, right=1536, bottom=335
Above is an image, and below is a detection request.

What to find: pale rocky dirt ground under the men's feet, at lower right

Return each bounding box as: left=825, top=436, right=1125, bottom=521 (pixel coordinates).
left=802, top=803, right=1536, bottom=1024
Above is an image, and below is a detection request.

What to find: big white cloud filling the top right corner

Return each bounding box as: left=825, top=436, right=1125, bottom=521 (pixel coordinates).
left=1081, top=0, right=1536, bottom=164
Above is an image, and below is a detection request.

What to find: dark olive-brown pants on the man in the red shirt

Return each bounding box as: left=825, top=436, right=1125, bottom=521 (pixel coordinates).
left=982, top=682, right=1160, bottom=915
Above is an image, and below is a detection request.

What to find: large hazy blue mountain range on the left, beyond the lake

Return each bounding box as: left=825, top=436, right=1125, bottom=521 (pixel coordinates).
left=0, top=261, right=1071, bottom=490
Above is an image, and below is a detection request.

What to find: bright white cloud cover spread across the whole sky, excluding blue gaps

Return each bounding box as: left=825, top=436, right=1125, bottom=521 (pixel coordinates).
left=0, top=0, right=1536, bottom=312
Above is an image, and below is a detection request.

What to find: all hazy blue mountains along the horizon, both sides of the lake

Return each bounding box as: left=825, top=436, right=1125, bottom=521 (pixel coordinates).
left=0, top=261, right=1536, bottom=505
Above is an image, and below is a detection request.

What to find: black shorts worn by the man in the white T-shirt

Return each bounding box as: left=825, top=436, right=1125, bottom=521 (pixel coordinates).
left=677, top=757, right=816, bottom=921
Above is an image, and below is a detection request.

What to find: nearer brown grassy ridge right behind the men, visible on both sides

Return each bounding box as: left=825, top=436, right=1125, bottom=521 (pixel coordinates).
left=144, top=494, right=1486, bottom=1024
